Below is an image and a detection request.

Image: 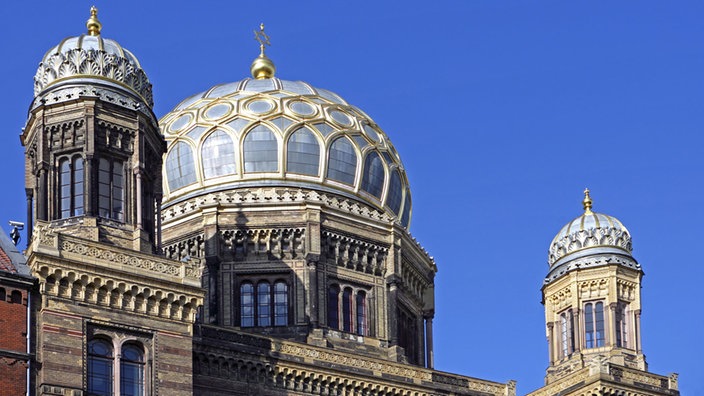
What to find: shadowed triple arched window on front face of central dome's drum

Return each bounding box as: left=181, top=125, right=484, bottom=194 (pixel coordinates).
left=240, top=281, right=288, bottom=327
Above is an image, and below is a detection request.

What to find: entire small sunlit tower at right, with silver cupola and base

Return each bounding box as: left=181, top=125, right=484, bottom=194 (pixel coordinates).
left=531, top=189, right=679, bottom=395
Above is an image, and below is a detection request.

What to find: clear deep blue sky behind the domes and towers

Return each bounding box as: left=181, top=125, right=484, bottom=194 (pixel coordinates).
left=0, top=0, right=704, bottom=395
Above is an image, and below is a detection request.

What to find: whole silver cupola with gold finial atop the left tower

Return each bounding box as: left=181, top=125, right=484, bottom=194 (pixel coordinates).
left=32, top=7, right=154, bottom=111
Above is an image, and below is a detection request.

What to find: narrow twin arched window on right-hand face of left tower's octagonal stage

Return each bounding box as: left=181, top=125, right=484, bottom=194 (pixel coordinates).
left=98, top=158, right=125, bottom=221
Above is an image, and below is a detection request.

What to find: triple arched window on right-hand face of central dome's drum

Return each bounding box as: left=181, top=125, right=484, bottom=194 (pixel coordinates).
left=328, top=285, right=369, bottom=336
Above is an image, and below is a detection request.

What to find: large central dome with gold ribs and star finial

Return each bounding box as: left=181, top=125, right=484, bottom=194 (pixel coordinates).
left=160, top=26, right=411, bottom=227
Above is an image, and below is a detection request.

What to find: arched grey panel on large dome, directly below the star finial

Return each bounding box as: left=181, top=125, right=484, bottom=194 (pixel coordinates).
left=244, top=125, right=279, bottom=172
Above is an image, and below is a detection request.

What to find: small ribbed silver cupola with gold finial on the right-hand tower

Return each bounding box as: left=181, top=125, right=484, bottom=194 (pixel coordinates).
left=545, top=189, right=640, bottom=283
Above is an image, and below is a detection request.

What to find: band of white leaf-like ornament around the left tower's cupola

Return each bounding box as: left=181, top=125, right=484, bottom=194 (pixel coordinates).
left=34, top=48, right=154, bottom=108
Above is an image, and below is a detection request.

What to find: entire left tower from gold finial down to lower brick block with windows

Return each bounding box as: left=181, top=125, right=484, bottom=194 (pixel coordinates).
left=21, top=8, right=203, bottom=396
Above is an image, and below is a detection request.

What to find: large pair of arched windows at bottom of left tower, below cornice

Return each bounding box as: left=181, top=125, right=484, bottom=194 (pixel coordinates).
left=88, top=338, right=145, bottom=396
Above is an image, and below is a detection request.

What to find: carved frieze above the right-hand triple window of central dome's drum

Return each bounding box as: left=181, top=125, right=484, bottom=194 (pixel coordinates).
left=320, top=231, right=389, bottom=276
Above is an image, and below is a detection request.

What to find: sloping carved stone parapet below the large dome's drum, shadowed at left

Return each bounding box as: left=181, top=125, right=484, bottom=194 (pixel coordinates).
left=194, top=326, right=515, bottom=396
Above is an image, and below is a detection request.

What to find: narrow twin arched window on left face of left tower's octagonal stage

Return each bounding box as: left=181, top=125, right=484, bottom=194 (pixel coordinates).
left=59, top=156, right=84, bottom=219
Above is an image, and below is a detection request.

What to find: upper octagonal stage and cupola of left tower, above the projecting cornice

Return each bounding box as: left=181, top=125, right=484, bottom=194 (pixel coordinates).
left=21, top=7, right=166, bottom=253
